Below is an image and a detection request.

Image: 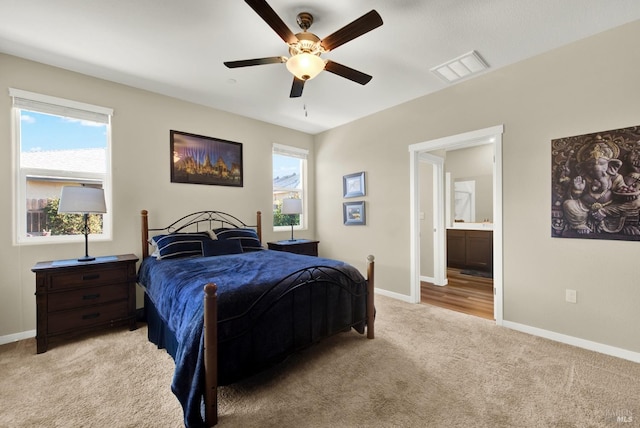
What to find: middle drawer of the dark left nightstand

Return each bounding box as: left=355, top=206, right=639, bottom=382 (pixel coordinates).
left=47, top=283, right=129, bottom=312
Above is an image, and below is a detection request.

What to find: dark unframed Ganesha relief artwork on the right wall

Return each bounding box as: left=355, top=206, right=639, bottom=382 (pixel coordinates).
left=551, top=126, right=640, bottom=241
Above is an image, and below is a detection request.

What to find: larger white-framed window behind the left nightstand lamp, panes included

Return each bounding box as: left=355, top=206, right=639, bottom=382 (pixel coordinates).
left=9, top=89, right=113, bottom=244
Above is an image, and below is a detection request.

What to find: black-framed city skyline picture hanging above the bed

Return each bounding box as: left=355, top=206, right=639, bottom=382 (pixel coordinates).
left=170, top=130, right=243, bottom=187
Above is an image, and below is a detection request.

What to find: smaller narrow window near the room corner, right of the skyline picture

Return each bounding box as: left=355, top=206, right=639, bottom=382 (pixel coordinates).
left=273, top=144, right=309, bottom=231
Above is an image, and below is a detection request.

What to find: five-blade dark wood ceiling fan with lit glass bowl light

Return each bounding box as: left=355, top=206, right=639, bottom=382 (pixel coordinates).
left=224, top=0, right=382, bottom=98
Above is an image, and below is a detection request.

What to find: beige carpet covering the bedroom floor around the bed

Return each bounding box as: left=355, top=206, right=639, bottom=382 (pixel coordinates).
left=0, top=297, right=640, bottom=428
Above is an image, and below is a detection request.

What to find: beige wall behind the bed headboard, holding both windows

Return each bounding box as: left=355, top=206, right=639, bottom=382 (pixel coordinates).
left=0, top=54, right=315, bottom=337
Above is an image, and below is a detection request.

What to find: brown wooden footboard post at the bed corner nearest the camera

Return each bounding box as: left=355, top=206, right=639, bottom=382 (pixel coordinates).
left=203, top=283, right=218, bottom=427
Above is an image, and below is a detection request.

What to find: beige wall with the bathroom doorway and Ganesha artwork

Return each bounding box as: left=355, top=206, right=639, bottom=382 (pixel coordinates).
left=316, top=21, right=640, bottom=352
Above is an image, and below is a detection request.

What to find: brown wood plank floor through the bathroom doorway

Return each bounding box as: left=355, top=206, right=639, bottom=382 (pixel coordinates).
left=420, top=268, right=494, bottom=320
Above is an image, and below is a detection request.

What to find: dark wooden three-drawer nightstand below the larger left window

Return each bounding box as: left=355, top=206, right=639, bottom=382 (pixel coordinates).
left=31, top=254, right=138, bottom=354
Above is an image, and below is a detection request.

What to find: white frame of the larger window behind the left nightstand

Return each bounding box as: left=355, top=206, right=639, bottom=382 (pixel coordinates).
left=9, top=88, right=113, bottom=246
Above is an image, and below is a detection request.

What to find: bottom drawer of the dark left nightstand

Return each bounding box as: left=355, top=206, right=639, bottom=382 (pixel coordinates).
left=47, top=301, right=129, bottom=334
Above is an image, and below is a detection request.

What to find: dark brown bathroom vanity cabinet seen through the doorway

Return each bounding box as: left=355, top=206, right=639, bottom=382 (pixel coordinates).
left=447, top=229, right=493, bottom=272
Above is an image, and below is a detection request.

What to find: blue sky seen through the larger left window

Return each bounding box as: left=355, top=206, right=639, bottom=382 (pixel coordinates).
left=20, top=110, right=107, bottom=152
